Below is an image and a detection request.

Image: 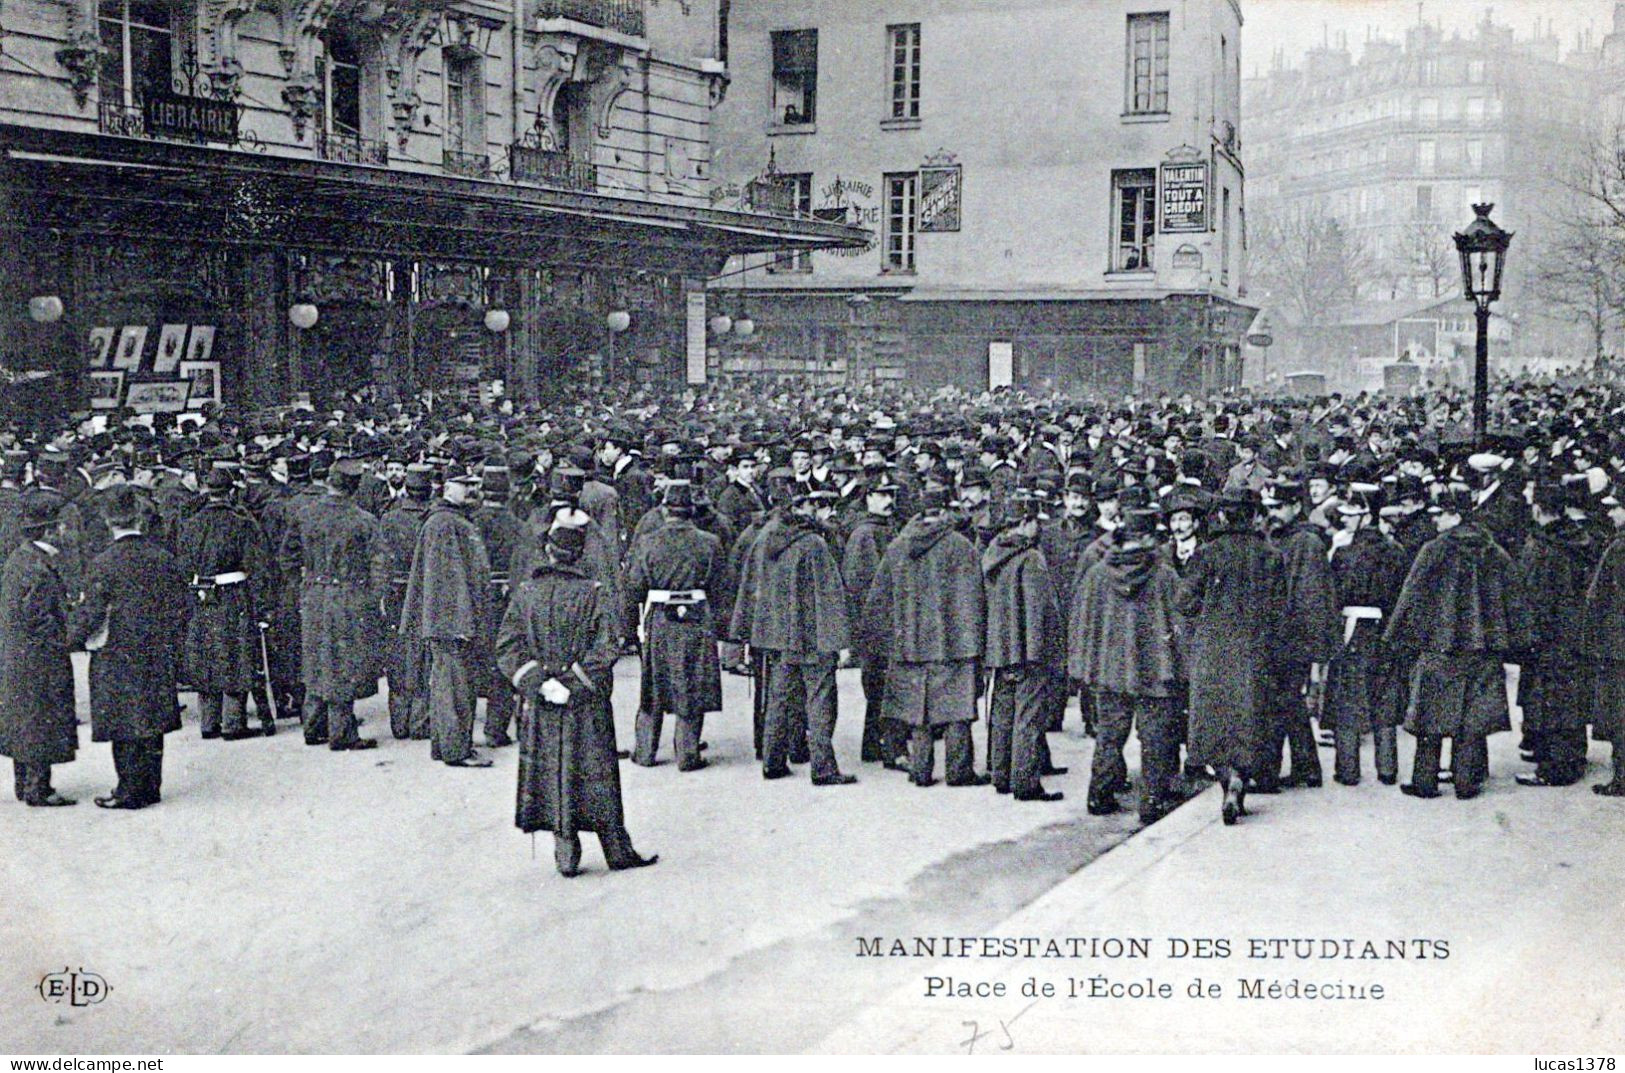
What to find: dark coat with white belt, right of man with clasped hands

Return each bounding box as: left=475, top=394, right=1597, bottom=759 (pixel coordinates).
left=627, top=517, right=726, bottom=715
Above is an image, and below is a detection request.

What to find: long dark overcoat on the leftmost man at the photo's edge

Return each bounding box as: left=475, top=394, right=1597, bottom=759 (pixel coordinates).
left=0, top=541, right=78, bottom=764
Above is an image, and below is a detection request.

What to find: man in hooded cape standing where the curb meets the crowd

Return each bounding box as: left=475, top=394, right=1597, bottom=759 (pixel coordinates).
left=1068, top=510, right=1185, bottom=823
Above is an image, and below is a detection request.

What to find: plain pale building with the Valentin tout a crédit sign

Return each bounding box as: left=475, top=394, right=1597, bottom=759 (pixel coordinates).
left=712, top=0, right=1251, bottom=392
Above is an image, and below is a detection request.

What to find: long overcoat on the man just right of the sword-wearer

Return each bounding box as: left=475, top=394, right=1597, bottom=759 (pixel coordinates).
left=299, top=496, right=390, bottom=702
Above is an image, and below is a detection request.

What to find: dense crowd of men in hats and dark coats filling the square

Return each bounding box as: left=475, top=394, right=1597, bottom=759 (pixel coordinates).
left=0, top=372, right=1625, bottom=875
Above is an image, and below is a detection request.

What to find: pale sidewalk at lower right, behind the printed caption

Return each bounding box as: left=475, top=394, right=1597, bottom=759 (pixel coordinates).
left=814, top=733, right=1625, bottom=1055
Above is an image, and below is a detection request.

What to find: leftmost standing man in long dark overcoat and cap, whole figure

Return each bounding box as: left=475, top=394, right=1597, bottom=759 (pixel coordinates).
left=0, top=488, right=78, bottom=808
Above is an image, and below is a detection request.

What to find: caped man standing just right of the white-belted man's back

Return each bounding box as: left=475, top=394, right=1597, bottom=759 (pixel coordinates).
left=731, top=491, right=856, bottom=785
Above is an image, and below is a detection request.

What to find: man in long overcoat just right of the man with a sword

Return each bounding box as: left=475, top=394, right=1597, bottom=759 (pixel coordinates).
left=284, top=458, right=390, bottom=753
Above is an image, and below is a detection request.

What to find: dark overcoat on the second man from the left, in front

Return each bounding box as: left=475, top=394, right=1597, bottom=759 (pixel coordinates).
left=68, top=535, right=197, bottom=741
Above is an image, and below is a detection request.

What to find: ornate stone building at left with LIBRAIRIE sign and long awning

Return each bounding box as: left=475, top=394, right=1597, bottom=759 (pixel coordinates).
left=0, top=0, right=865, bottom=408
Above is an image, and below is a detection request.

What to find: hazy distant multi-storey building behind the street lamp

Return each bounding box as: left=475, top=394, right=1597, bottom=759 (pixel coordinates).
left=1242, top=15, right=1602, bottom=382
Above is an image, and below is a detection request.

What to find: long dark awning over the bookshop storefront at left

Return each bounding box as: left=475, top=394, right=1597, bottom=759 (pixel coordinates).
left=0, top=124, right=869, bottom=276
